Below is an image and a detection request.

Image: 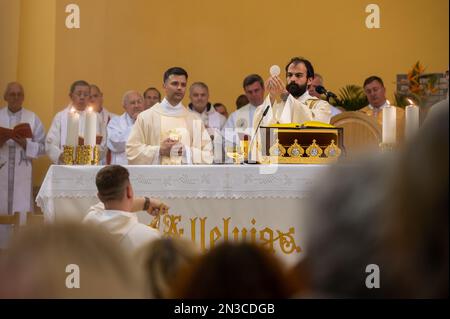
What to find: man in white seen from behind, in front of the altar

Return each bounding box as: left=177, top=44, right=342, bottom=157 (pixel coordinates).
left=83, top=165, right=161, bottom=252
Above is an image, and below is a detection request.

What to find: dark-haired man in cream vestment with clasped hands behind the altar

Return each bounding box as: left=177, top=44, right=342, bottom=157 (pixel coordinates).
left=126, top=67, right=213, bottom=165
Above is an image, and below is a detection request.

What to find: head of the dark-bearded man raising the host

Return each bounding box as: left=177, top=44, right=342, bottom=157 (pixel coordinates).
left=285, top=57, right=314, bottom=98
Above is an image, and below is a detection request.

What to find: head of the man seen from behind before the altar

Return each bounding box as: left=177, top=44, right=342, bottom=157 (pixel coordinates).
left=95, top=165, right=134, bottom=212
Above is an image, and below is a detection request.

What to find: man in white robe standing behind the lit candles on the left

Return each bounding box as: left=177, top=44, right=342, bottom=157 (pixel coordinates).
left=45, top=81, right=106, bottom=164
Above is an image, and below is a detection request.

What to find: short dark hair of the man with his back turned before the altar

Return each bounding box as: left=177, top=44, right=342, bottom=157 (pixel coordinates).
left=95, top=165, right=130, bottom=202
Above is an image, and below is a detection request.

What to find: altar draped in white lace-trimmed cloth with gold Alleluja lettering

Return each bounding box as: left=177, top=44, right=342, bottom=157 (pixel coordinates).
left=36, top=165, right=329, bottom=264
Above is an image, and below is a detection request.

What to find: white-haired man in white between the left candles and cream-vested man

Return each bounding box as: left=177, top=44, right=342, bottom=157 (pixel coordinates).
left=106, top=91, right=145, bottom=165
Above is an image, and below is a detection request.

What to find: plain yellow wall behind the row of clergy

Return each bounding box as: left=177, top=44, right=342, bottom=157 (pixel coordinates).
left=0, top=0, right=449, bottom=188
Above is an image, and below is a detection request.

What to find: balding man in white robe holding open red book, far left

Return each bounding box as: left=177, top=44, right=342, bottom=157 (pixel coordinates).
left=0, top=82, right=45, bottom=248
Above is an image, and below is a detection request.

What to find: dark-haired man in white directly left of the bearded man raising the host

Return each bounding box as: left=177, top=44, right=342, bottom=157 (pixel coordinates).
left=222, top=74, right=265, bottom=148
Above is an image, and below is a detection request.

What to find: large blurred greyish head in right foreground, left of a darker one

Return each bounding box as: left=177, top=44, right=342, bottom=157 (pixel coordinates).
left=298, top=154, right=395, bottom=298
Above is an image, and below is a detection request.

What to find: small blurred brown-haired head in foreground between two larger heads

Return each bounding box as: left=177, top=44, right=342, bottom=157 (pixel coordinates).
left=136, top=238, right=199, bottom=298
